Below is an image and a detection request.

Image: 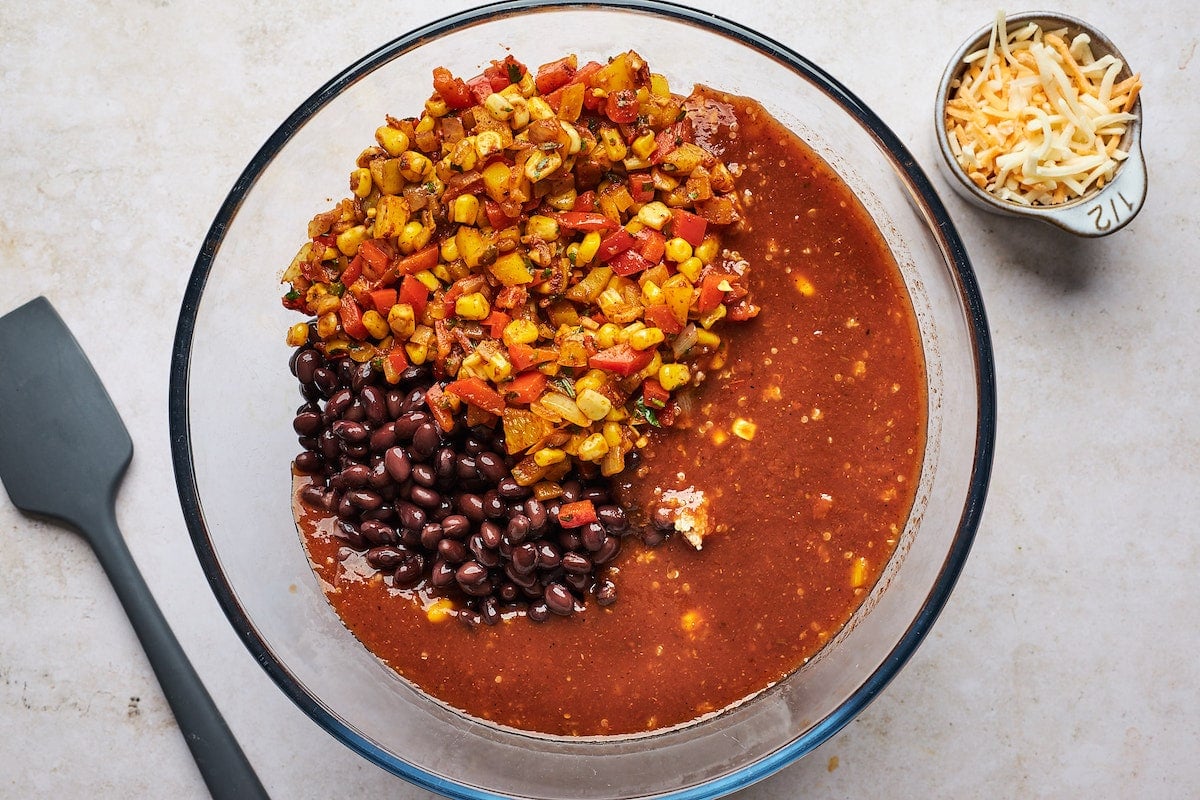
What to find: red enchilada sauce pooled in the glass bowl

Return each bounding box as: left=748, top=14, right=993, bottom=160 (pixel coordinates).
left=298, top=92, right=926, bottom=735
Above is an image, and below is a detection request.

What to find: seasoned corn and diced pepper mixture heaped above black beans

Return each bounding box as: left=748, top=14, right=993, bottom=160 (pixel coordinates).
left=283, top=52, right=758, bottom=497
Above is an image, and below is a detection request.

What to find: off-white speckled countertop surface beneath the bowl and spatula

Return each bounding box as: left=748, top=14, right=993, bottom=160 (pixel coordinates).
left=0, top=0, right=1200, bottom=800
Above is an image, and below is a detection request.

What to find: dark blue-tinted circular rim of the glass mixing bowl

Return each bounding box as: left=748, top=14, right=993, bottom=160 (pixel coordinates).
left=168, top=0, right=996, bottom=800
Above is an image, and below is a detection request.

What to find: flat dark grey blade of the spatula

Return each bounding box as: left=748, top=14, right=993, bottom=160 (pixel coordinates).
left=0, top=297, right=133, bottom=527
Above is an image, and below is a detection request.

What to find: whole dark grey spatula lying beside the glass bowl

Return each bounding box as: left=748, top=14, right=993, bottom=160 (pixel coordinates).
left=0, top=297, right=266, bottom=800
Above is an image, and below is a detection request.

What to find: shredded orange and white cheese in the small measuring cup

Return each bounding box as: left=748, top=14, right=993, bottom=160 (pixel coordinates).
left=946, top=12, right=1141, bottom=205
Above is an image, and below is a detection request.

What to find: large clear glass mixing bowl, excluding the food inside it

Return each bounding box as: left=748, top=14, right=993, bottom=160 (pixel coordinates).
left=170, top=1, right=995, bottom=800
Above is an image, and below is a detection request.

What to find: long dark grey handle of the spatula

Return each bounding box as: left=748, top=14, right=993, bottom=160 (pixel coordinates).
left=87, top=507, right=268, bottom=800
